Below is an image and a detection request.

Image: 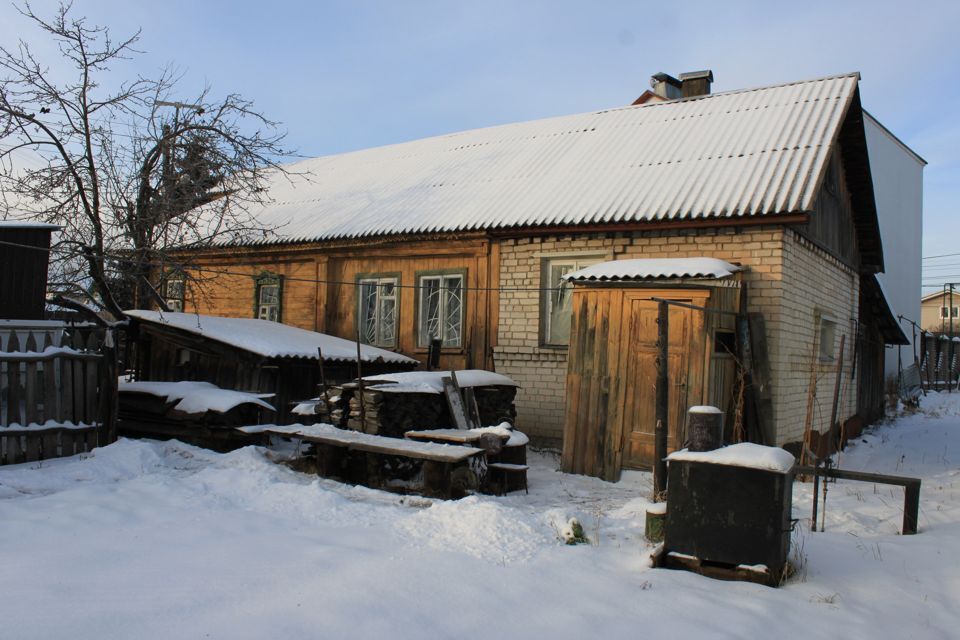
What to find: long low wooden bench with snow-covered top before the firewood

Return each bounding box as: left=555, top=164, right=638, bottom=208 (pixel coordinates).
left=263, top=425, right=483, bottom=498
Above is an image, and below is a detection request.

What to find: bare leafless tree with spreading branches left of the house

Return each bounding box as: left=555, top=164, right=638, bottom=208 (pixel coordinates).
left=0, top=4, right=287, bottom=317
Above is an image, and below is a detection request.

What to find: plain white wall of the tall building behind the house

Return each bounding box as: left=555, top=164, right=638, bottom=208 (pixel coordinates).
left=864, top=112, right=926, bottom=376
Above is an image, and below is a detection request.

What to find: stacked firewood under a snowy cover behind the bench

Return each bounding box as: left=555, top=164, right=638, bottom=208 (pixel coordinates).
left=338, top=383, right=517, bottom=438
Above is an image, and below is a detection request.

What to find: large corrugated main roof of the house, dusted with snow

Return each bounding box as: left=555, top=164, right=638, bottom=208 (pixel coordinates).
left=219, top=74, right=858, bottom=242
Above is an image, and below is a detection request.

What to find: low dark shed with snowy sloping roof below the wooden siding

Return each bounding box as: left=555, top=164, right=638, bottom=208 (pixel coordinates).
left=125, top=310, right=419, bottom=424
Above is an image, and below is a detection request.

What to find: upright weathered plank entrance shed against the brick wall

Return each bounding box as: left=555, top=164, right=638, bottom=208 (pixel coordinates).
left=563, top=257, right=742, bottom=480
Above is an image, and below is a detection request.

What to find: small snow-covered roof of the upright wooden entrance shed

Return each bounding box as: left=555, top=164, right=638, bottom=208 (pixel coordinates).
left=564, top=258, right=740, bottom=282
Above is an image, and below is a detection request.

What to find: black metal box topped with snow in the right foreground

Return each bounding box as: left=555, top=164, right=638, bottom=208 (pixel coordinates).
left=663, top=460, right=794, bottom=584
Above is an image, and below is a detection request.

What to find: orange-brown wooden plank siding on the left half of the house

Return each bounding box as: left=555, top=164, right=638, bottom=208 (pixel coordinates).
left=175, top=236, right=499, bottom=369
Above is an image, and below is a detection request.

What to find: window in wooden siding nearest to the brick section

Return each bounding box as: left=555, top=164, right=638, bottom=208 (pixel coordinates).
left=417, top=273, right=464, bottom=347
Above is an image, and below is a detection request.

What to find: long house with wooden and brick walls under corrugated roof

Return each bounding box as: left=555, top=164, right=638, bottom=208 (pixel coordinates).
left=167, top=72, right=906, bottom=477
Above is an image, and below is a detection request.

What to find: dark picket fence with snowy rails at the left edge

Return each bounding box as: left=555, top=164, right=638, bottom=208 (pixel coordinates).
left=0, top=326, right=117, bottom=464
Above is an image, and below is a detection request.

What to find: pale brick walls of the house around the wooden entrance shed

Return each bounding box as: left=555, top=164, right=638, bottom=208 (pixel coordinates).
left=494, top=227, right=859, bottom=448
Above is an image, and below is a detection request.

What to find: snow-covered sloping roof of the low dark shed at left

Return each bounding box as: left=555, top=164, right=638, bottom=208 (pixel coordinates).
left=124, top=310, right=417, bottom=364
